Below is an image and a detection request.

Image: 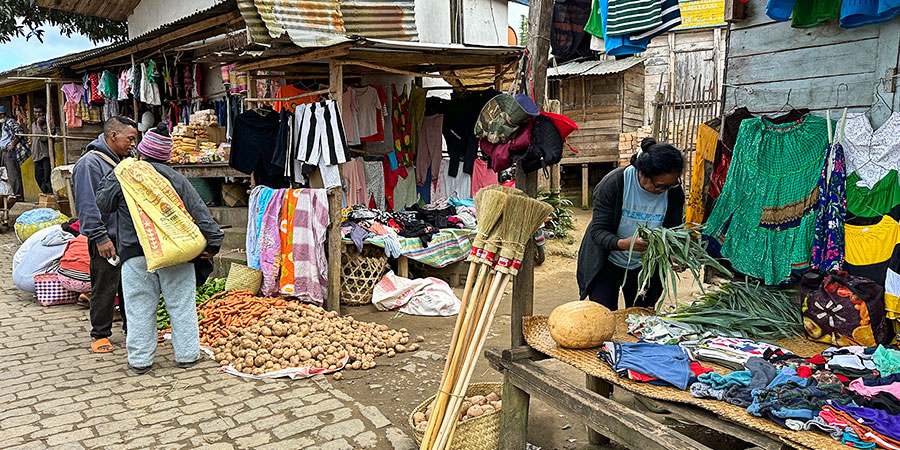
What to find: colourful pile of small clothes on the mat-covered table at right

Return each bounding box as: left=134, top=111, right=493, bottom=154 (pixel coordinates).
left=597, top=328, right=900, bottom=449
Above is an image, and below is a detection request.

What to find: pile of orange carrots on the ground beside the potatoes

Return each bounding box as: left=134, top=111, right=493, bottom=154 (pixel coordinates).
left=198, top=290, right=288, bottom=346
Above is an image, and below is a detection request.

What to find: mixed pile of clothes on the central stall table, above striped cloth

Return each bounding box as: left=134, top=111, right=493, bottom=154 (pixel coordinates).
left=341, top=198, right=477, bottom=258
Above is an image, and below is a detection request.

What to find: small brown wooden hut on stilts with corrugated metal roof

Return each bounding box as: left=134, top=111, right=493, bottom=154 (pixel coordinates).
left=547, top=57, right=644, bottom=207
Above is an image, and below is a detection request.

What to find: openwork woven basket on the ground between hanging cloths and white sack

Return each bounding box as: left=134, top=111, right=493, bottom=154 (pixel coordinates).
left=341, top=247, right=387, bottom=305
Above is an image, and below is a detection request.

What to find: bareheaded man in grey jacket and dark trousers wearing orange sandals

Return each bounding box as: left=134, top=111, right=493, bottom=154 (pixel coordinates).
left=72, top=116, right=137, bottom=353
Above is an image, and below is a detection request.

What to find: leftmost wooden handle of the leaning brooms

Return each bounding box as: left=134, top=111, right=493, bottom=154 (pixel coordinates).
left=419, top=264, right=489, bottom=450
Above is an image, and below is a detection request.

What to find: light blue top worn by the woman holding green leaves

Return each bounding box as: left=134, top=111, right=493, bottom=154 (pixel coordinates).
left=609, top=166, right=669, bottom=269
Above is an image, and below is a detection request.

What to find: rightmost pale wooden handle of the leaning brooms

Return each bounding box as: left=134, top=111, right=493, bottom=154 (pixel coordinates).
left=434, top=273, right=511, bottom=450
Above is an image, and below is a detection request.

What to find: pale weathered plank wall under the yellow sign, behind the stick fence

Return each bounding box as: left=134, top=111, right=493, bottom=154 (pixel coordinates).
left=644, top=28, right=726, bottom=124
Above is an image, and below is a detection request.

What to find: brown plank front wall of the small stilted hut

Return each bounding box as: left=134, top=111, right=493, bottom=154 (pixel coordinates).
left=557, top=73, right=625, bottom=164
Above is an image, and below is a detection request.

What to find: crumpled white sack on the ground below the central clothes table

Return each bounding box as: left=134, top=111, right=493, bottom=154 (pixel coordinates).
left=372, top=271, right=461, bottom=316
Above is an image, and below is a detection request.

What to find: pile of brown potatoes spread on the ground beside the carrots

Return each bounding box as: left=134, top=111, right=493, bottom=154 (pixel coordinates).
left=213, top=305, right=424, bottom=375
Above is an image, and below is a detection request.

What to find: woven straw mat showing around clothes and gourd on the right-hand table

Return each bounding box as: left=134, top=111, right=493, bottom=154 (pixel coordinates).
left=522, top=308, right=847, bottom=450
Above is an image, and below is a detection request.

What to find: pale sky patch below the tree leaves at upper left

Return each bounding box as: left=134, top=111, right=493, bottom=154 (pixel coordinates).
left=0, top=26, right=102, bottom=71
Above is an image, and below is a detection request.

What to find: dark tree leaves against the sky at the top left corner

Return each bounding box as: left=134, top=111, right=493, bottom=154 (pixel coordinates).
left=0, top=0, right=128, bottom=44
